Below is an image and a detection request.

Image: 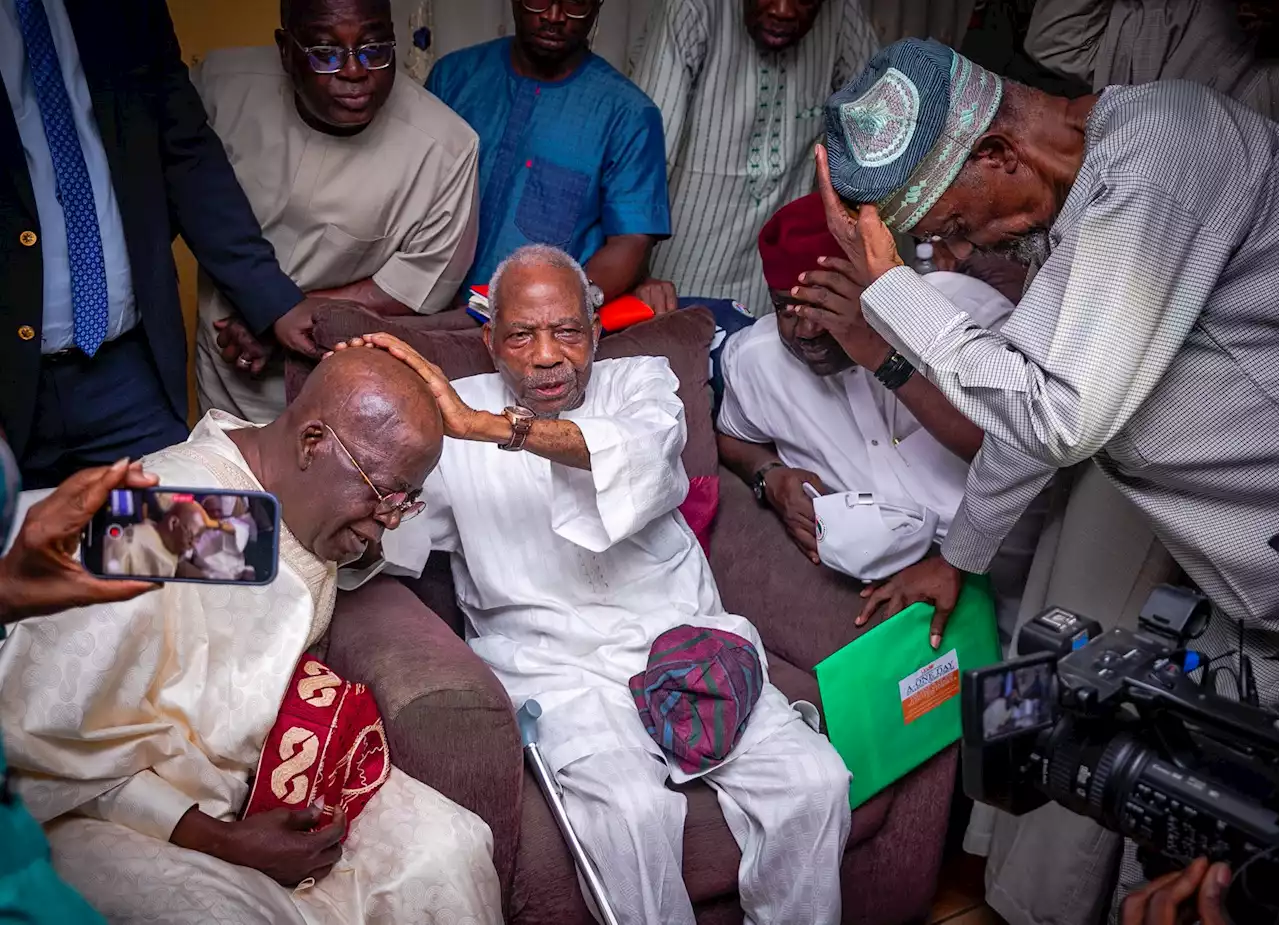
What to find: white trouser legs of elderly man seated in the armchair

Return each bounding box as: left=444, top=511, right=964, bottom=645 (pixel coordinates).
left=557, top=690, right=851, bottom=925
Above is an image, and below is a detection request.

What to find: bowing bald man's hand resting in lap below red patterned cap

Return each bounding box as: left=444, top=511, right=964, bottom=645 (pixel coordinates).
left=216, top=803, right=347, bottom=887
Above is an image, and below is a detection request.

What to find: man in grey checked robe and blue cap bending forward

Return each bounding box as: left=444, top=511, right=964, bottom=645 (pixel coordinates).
left=804, top=40, right=1280, bottom=925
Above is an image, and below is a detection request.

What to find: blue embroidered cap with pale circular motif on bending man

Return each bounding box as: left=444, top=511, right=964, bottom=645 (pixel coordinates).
left=826, top=38, right=1004, bottom=232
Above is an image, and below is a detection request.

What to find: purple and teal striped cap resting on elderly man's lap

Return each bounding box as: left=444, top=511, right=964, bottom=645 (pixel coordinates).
left=630, top=626, right=764, bottom=774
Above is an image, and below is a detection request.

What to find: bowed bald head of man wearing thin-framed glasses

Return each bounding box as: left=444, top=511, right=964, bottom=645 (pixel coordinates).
left=250, top=347, right=444, bottom=563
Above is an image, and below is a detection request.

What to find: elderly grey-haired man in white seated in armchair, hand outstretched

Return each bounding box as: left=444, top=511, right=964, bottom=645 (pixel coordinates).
left=345, top=246, right=851, bottom=925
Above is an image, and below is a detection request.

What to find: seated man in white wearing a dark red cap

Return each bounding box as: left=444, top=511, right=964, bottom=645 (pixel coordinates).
left=719, top=193, right=1038, bottom=632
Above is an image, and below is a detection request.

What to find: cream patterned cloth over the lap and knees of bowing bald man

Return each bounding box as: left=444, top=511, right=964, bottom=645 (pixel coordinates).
left=47, top=769, right=502, bottom=925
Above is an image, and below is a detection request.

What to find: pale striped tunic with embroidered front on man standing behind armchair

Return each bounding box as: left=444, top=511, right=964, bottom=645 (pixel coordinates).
left=631, top=0, right=878, bottom=317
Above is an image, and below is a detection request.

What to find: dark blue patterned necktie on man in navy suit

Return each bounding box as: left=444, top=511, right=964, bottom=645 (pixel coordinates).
left=14, top=0, right=108, bottom=356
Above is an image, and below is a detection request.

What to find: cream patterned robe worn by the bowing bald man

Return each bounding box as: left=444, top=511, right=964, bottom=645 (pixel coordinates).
left=0, top=412, right=502, bottom=925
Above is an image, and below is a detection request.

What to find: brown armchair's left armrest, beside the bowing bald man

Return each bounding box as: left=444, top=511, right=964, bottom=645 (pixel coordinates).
left=328, top=577, right=525, bottom=898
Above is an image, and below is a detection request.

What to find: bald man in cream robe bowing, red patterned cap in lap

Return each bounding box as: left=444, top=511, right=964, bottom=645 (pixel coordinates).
left=0, top=351, right=502, bottom=925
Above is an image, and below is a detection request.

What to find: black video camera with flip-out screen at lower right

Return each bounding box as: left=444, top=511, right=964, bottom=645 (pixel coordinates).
left=961, top=586, right=1280, bottom=925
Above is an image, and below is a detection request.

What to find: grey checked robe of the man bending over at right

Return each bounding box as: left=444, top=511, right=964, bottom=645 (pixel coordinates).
left=863, top=81, right=1280, bottom=632
